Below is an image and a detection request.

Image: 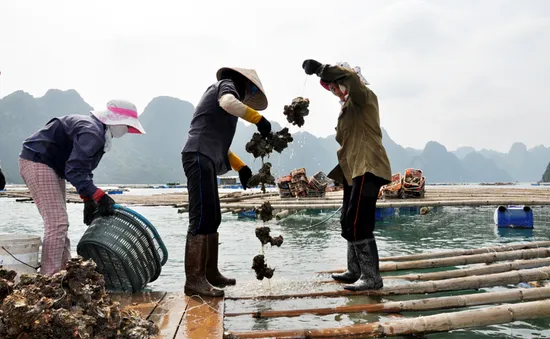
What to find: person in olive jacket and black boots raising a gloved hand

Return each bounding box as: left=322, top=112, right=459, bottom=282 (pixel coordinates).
left=302, top=59, right=391, bottom=291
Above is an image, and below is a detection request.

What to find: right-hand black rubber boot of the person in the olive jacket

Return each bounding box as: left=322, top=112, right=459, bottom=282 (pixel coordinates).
left=344, top=239, right=384, bottom=291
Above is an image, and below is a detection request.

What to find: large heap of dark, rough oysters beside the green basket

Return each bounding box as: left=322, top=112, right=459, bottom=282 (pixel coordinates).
left=0, top=257, right=159, bottom=339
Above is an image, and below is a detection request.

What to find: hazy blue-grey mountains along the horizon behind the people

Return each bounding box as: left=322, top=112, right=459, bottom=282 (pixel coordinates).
left=0, top=89, right=550, bottom=184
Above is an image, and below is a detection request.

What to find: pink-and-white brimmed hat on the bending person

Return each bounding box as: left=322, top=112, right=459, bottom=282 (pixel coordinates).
left=90, top=100, right=145, bottom=134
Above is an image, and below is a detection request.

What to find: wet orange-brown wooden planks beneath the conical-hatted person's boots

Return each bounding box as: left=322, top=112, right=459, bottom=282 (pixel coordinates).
left=112, top=292, right=224, bottom=339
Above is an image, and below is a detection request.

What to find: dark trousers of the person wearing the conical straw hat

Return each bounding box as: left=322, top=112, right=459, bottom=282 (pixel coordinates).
left=181, top=152, right=222, bottom=235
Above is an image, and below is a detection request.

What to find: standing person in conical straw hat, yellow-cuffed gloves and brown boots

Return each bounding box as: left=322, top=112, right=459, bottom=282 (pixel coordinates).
left=182, top=67, right=271, bottom=296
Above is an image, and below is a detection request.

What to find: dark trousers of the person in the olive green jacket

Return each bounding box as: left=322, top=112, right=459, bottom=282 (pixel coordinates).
left=340, top=173, right=387, bottom=241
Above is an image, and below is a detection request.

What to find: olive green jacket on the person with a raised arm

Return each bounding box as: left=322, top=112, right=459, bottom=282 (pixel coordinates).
left=318, top=65, right=391, bottom=185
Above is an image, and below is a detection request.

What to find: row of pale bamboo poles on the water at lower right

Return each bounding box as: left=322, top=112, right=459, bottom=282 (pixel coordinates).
left=224, top=241, right=550, bottom=339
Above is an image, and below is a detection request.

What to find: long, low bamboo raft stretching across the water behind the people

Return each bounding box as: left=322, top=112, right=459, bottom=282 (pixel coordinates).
left=5, top=186, right=550, bottom=212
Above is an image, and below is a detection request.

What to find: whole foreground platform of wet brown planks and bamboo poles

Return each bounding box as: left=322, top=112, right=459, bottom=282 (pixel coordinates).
left=109, top=241, right=550, bottom=339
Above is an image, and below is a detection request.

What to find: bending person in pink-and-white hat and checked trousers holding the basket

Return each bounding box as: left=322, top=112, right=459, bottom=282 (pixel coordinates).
left=19, top=100, right=145, bottom=274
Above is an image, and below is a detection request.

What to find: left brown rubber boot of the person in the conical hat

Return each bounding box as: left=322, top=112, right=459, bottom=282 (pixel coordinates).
left=184, top=233, right=224, bottom=297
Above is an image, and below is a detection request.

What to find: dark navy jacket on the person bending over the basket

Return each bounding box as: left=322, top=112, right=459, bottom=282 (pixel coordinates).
left=19, top=115, right=106, bottom=198
